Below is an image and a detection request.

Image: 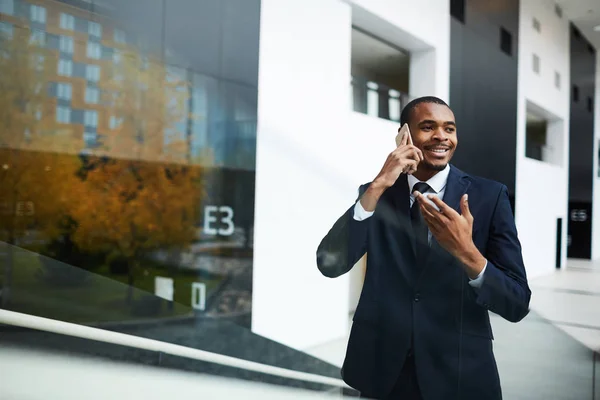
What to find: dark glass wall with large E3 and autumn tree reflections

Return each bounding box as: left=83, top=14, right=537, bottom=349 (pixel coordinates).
left=0, top=0, right=260, bottom=327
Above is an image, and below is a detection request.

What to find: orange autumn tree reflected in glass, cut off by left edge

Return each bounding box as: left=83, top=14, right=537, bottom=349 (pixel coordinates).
left=0, top=25, right=80, bottom=244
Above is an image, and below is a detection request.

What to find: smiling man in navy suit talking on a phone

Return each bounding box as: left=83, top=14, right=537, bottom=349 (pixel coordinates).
left=317, top=97, right=531, bottom=400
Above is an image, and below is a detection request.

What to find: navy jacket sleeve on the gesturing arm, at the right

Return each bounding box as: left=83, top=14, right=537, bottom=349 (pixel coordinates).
left=476, top=186, right=531, bottom=322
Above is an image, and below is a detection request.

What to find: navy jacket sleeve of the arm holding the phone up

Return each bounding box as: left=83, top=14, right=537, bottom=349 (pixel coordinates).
left=317, top=184, right=373, bottom=278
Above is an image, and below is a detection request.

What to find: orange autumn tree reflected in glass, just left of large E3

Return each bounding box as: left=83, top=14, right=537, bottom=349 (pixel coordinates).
left=71, top=38, right=203, bottom=297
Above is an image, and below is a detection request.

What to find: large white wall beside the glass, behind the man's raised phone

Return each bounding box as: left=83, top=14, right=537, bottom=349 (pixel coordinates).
left=252, top=0, right=450, bottom=349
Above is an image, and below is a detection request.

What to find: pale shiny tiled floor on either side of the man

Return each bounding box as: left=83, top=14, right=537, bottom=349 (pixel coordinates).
left=307, top=260, right=600, bottom=400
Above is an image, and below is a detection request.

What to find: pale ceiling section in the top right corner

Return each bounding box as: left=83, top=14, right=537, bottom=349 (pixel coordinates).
left=556, top=0, right=600, bottom=51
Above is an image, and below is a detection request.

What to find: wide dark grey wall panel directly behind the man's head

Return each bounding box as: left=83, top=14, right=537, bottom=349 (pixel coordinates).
left=450, top=0, right=519, bottom=200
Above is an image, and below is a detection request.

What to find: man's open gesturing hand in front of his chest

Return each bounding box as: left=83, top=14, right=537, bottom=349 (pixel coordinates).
left=415, top=192, right=487, bottom=279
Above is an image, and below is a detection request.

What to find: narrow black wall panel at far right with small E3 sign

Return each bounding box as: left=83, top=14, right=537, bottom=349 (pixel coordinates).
left=567, top=25, right=597, bottom=259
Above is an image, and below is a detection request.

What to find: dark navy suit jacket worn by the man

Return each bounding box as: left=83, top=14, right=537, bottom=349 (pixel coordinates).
left=317, top=167, right=531, bottom=400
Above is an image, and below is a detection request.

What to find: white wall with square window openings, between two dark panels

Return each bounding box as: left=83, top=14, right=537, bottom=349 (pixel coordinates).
left=515, top=0, right=570, bottom=278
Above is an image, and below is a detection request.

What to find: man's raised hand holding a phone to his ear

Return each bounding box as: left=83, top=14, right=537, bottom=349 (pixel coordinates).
left=360, top=124, right=423, bottom=212
